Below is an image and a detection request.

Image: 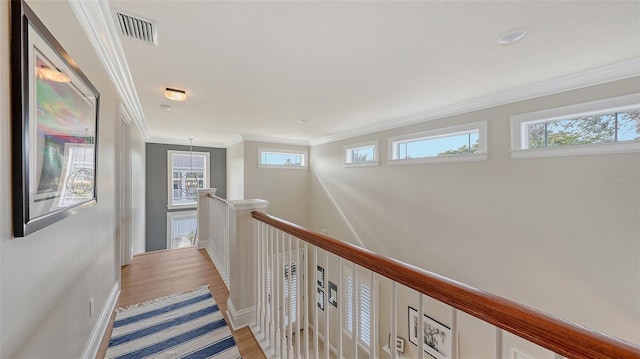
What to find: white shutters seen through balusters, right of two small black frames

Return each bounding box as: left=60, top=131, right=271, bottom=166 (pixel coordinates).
left=345, top=274, right=373, bottom=348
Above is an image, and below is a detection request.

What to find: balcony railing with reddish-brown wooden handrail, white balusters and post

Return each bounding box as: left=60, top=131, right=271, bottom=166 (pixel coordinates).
left=198, top=194, right=640, bottom=359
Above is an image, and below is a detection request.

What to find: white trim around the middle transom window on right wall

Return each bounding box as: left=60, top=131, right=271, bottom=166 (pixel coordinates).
left=388, top=121, right=489, bottom=165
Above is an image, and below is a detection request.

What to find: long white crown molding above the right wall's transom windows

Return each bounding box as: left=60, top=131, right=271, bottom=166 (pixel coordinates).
left=309, top=58, right=640, bottom=146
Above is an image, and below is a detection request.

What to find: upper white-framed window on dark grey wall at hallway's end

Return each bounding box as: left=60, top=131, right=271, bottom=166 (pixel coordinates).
left=167, top=151, right=210, bottom=208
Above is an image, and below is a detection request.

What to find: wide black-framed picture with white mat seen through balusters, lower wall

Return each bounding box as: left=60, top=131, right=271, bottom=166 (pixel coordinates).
left=408, top=307, right=452, bottom=359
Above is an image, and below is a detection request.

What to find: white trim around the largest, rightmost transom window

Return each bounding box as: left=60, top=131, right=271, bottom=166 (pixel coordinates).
left=510, top=93, right=640, bottom=159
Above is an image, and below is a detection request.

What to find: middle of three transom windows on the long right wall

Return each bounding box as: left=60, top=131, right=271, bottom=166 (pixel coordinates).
left=389, top=121, right=487, bottom=163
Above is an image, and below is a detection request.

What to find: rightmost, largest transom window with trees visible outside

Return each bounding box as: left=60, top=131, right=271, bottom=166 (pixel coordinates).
left=511, top=94, right=640, bottom=158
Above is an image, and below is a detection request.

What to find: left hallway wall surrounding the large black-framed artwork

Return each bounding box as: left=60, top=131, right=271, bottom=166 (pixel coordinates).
left=0, top=1, right=120, bottom=358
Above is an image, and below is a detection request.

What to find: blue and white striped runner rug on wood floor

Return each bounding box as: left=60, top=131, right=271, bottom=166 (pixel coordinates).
left=105, top=286, right=240, bottom=359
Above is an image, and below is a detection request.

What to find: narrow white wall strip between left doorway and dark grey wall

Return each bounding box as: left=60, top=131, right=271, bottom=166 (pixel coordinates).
left=130, top=123, right=146, bottom=254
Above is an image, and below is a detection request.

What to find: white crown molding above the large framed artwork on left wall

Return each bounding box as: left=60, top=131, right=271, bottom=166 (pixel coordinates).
left=68, top=0, right=149, bottom=140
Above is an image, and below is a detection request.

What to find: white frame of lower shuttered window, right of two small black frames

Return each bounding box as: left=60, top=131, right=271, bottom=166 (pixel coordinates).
left=341, top=265, right=379, bottom=353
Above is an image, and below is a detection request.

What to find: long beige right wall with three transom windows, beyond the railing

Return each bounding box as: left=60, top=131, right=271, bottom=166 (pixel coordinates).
left=308, top=78, right=640, bottom=358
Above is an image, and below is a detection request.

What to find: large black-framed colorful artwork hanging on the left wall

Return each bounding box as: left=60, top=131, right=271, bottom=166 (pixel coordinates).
left=11, top=0, right=100, bottom=237
